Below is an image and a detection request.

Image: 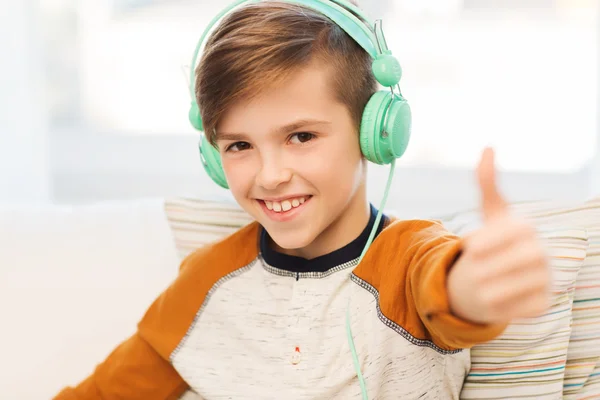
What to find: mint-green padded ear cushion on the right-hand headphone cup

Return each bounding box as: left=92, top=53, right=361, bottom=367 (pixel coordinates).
left=360, top=90, right=393, bottom=164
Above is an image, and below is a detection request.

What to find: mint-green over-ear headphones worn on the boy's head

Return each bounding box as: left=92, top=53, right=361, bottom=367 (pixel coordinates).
left=189, top=0, right=412, bottom=189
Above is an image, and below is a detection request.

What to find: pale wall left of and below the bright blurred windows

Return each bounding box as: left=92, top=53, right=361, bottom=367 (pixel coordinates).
left=0, top=0, right=600, bottom=212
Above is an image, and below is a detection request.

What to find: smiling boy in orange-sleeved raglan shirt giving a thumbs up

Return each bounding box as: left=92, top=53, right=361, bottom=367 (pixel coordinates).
left=57, top=0, right=549, bottom=400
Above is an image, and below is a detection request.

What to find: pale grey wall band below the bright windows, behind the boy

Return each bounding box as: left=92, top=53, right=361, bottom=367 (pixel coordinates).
left=44, top=0, right=600, bottom=217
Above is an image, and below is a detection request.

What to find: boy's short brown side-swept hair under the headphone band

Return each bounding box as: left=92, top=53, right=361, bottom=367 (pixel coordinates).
left=195, top=1, right=377, bottom=145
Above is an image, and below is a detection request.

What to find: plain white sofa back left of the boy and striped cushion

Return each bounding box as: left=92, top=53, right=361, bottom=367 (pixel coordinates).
left=0, top=198, right=179, bottom=400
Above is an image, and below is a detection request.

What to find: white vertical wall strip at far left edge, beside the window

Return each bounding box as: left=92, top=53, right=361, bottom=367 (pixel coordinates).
left=0, top=0, right=50, bottom=203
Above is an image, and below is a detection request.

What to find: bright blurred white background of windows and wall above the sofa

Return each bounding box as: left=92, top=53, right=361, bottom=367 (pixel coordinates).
left=0, top=0, right=600, bottom=216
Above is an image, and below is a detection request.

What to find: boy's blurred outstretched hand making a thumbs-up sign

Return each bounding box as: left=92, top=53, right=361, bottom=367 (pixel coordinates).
left=447, top=149, right=550, bottom=324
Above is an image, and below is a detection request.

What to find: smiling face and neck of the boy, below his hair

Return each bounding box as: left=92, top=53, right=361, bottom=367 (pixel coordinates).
left=217, top=63, right=369, bottom=258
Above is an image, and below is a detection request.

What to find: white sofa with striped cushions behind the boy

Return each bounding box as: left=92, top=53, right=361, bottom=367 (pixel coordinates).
left=0, top=198, right=600, bottom=400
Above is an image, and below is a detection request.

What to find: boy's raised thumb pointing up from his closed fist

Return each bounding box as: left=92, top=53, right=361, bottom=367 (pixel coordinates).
left=477, top=147, right=508, bottom=220
